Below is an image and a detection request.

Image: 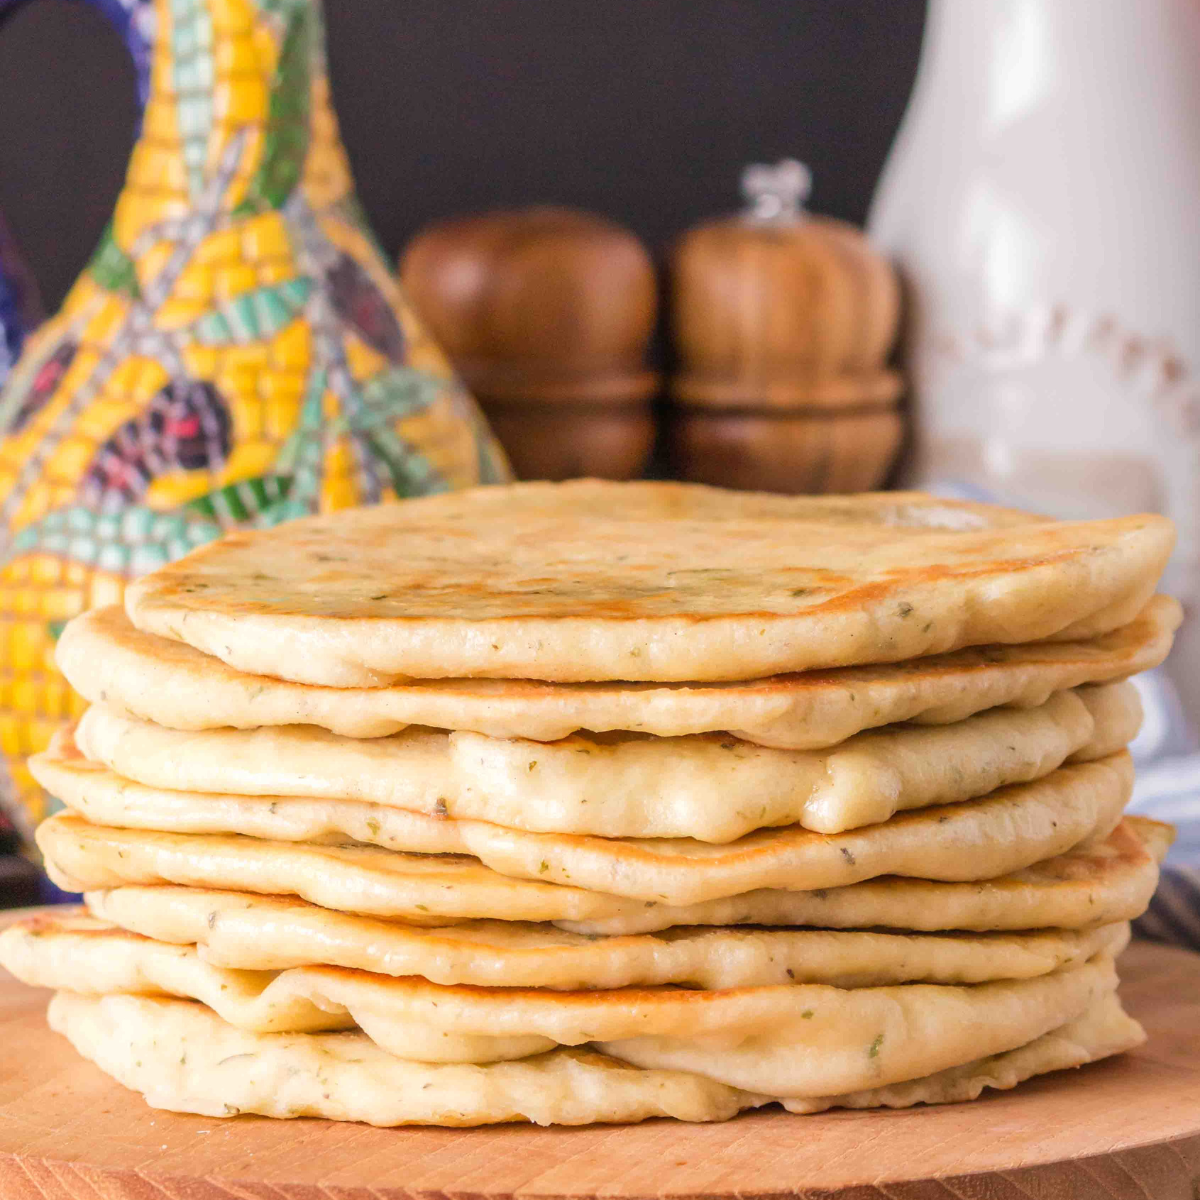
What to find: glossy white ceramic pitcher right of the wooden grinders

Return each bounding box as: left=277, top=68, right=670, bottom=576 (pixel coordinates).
left=869, top=0, right=1200, bottom=719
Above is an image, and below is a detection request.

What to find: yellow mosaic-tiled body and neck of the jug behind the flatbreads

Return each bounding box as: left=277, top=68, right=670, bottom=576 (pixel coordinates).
left=0, top=0, right=508, bottom=829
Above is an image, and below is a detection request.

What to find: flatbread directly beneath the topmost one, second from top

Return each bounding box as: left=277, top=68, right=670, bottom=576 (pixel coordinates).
left=56, top=596, right=1182, bottom=750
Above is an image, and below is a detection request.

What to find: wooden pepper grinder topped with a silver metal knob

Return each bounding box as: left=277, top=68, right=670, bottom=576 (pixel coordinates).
left=671, top=160, right=901, bottom=492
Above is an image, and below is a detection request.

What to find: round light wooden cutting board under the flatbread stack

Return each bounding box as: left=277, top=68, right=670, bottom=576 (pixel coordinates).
left=0, top=912, right=1200, bottom=1200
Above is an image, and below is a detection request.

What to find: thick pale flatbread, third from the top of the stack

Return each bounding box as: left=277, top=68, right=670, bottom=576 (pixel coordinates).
left=74, top=683, right=1141, bottom=842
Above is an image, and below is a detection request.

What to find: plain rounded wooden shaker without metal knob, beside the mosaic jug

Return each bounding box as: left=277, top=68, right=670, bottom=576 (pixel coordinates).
left=401, top=206, right=658, bottom=479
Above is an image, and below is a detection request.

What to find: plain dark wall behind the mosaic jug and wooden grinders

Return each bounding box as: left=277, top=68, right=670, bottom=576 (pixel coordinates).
left=0, top=0, right=924, bottom=310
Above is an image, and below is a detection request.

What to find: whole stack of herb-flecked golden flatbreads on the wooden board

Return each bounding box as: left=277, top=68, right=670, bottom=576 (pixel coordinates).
left=0, top=482, right=1178, bottom=1126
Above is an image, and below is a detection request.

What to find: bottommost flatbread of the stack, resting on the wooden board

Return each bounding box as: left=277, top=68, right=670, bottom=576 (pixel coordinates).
left=49, top=992, right=1145, bottom=1127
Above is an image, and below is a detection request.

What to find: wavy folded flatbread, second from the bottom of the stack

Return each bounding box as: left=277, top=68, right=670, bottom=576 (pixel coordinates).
left=0, top=916, right=1116, bottom=1096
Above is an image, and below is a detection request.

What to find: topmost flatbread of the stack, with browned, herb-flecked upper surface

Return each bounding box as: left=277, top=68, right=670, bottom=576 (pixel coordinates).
left=126, top=480, right=1175, bottom=688
